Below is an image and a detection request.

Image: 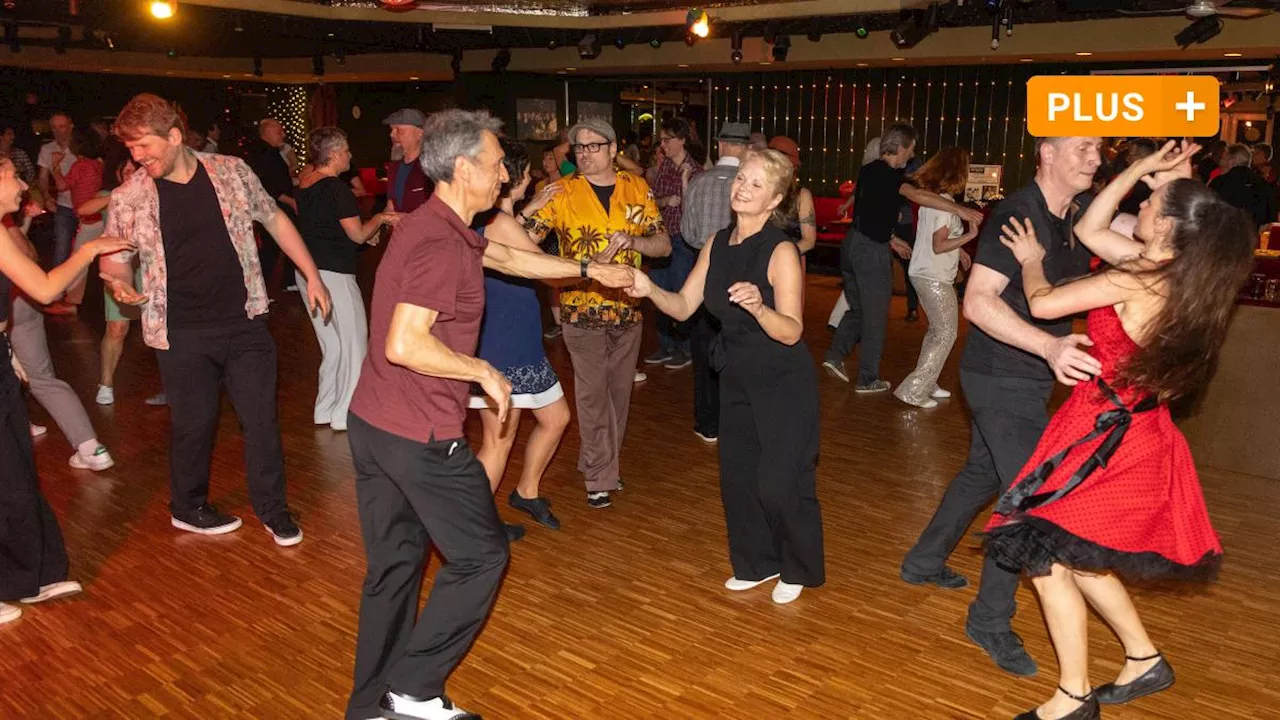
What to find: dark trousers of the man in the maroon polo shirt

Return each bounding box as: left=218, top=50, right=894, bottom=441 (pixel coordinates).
left=347, top=413, right=507, bottom=720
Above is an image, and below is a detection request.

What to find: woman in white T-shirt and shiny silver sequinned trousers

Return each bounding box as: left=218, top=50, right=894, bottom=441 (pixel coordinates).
left=893, top=147, right=978, bottom=407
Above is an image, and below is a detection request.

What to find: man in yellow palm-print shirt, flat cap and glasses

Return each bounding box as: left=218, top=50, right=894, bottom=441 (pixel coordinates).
left=522, top=119, right=671, bottom=507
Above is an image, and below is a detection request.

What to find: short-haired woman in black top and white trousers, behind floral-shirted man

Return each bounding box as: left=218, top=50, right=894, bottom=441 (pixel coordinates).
left=294, top=127, right=398, bottom=430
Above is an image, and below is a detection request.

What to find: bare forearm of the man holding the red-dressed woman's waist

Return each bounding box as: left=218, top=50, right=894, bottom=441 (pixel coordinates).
left=964, top=264, right=1102, bottom=386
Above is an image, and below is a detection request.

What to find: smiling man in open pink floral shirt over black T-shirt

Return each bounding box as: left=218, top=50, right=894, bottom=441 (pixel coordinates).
left=102, top=94, right=329, bottom=546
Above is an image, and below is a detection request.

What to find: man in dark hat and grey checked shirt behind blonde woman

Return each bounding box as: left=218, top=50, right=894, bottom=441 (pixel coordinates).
left=676, top=122, right=751, bottom=442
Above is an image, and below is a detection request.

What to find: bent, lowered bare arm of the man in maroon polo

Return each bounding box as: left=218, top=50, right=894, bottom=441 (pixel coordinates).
left=383, top=302, right=511, bottom=420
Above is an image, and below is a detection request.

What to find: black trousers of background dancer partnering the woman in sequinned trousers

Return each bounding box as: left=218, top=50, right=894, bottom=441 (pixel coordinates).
left=826, top=229, right=910, bottom=386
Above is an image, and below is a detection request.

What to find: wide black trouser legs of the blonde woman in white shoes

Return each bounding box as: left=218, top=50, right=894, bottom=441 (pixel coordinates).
left=719, top=356, right=826, bottom=587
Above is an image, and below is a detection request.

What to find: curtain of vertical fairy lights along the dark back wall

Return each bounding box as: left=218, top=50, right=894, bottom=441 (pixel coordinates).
left=709, top=67, right=1034, bottom=192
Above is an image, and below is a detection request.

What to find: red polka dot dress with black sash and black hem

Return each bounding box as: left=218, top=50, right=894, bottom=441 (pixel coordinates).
left=987, top=307, right=1222, bottom=580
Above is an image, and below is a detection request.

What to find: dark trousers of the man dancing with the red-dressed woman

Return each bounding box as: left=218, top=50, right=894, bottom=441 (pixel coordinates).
left=902, top=370, right=1053, bottom=633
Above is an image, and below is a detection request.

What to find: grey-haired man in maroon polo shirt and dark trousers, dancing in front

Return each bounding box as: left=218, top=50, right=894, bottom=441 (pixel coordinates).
left=347, top=110, right=632, bottom=720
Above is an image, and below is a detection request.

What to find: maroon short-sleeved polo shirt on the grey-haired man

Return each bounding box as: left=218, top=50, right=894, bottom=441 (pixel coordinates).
left=351, top=195, right=485, bottom=442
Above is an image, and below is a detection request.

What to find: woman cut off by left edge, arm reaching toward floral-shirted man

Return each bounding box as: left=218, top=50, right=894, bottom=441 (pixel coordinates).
left=0, top=158, right=128, bottom=624
